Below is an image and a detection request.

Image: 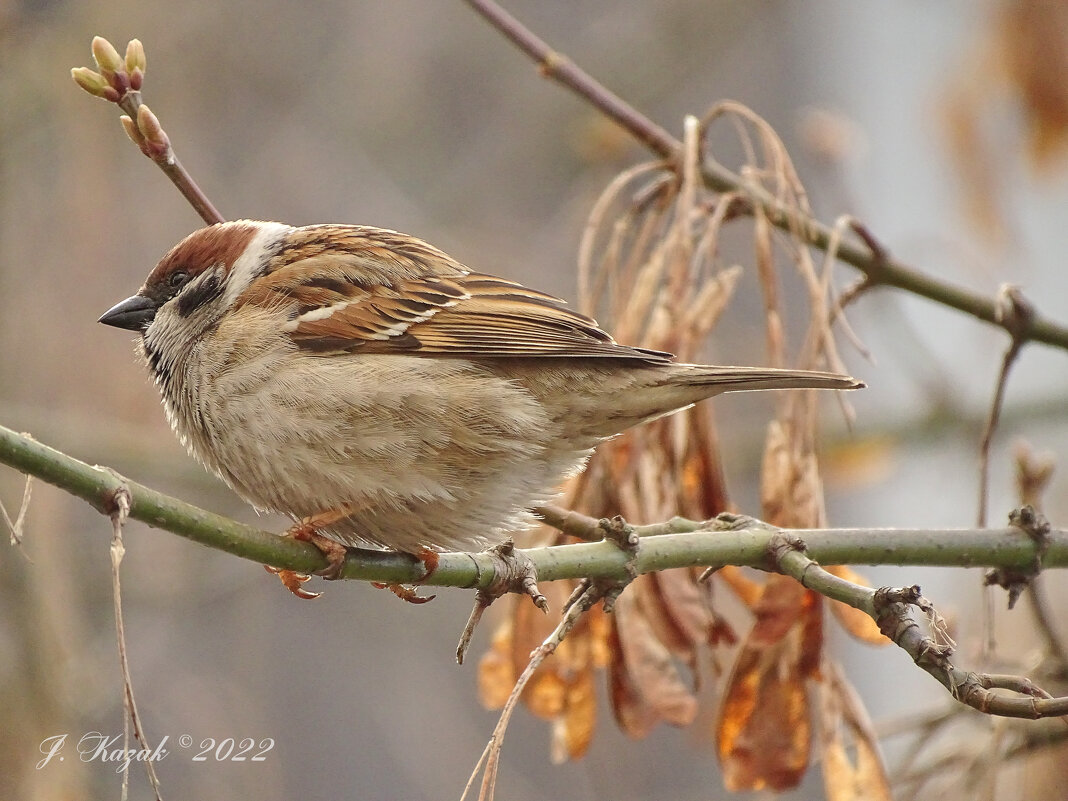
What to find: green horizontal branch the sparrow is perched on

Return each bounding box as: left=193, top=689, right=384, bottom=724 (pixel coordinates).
left=0, top=426, right=1068, bottom=585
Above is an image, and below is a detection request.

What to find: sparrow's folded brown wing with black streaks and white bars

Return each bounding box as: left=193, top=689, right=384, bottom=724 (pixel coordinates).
left=238, top=235, right=671, bottom=363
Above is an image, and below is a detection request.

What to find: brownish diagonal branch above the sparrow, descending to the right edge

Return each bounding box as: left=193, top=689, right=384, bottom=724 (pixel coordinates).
left=467, top=0, right=1068, bottom=350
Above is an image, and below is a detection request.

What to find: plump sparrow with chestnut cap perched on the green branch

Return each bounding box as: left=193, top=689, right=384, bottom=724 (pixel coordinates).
left=99, top=220, right=864, bottom=585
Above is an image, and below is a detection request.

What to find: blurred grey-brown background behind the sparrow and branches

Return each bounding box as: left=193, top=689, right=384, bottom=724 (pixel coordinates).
left=0, top=0, right=1068, bottom=801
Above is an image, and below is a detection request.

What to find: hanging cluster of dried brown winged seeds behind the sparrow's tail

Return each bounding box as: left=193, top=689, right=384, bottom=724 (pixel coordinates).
left=480, top=95, right=862, bottom=787
